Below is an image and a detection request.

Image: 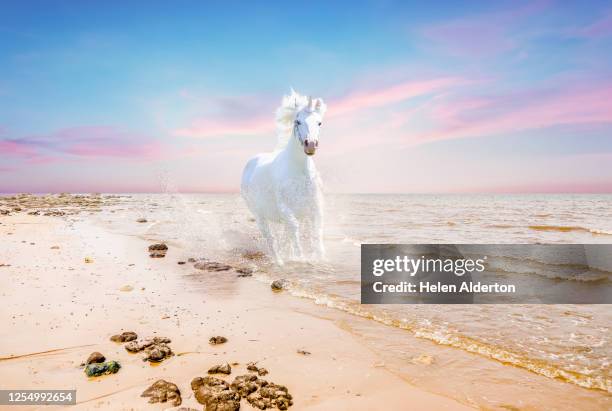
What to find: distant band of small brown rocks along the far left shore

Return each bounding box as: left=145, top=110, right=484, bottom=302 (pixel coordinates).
left=0, top=193, right=118, bottom=217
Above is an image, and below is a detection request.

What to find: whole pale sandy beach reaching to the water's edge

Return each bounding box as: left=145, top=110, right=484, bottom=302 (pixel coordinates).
left=0, top=196, right=610, bottom=410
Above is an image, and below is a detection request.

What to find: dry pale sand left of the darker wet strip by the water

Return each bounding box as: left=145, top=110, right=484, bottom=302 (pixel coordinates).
left=0, top=213, right=469, bottom=410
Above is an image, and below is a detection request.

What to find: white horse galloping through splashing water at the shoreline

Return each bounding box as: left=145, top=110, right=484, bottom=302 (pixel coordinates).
left=240, top=89, right=327, bottom=264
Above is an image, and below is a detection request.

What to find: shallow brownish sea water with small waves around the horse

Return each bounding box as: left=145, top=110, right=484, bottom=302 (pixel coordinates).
left=98, top=194, right=612, bottom=406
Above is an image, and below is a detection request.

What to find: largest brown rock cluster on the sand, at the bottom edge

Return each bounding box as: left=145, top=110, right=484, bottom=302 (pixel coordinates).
left=191, top=374, right=293, bottom=411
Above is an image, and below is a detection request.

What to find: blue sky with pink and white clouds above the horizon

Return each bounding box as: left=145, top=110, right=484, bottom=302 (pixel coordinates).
left=0, top=1, right=612, bottom=192
